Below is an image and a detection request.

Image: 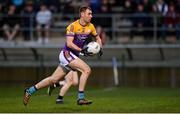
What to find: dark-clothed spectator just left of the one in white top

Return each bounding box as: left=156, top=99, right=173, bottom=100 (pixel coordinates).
left=22, top=4, right=35, bottom=41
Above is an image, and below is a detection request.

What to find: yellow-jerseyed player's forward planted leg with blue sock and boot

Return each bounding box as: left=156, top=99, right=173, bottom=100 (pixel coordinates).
left=69, top=58, right=92, bottom=105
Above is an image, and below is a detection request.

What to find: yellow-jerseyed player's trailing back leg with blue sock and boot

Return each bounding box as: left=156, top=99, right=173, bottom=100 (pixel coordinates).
left=23, top=66, right=66, bottom=106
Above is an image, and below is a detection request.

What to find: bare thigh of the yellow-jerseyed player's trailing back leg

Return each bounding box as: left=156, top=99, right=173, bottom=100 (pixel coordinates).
left=51, top=66, right=66, bottom=79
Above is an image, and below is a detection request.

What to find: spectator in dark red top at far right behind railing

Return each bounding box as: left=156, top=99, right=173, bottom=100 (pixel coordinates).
left=162, top=5, right=176, bottom=43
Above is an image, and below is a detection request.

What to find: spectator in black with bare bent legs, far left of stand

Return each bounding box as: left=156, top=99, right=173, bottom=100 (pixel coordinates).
left=3, top=5, right=20, bottom=40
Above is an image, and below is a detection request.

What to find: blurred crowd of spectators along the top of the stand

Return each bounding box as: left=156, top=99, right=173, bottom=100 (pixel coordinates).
left=0, top=0, right=180, bottom=43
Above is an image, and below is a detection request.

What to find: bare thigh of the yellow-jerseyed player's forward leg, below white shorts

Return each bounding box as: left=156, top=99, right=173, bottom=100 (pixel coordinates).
left=68, top=58, right=91, bottom=72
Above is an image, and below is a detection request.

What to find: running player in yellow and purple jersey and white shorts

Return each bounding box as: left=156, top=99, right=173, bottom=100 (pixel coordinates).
left=23, top=6, right=102, bottom=106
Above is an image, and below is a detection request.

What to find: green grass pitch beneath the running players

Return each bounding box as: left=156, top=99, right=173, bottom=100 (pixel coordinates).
left=0, top=87, right=180, bottom=113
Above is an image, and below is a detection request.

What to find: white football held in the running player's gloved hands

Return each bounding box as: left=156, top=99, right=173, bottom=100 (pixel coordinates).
left=87, top=41, right=101, bottom=54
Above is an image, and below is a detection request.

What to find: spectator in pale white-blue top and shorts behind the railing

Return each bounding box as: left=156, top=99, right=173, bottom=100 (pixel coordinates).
left=36, top=4, right=52, bottom=43
